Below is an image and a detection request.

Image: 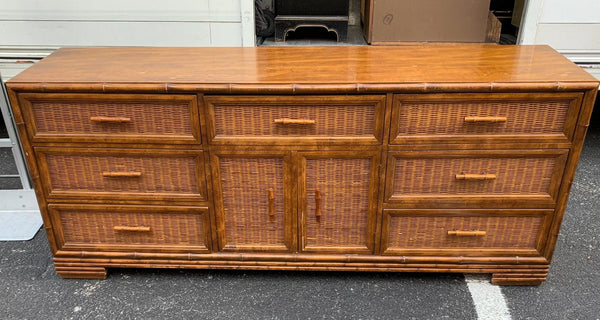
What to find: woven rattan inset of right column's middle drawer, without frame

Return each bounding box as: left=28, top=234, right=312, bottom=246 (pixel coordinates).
left=393, top=157, right=556, bottom=196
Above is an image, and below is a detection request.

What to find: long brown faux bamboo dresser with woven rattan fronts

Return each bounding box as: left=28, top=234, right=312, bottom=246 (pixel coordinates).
left=8, top=45, right=598, bottom=284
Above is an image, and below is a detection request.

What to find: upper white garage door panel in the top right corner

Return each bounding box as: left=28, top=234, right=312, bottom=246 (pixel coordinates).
left=539, top=0, right=600, bottom=23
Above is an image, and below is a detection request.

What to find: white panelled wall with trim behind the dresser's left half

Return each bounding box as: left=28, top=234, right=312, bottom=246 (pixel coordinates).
left=0, top=0, right=254, bottom=48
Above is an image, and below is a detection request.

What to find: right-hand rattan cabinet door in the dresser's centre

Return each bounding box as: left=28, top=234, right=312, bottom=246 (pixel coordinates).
left=298, top=151, right=379, bottom=253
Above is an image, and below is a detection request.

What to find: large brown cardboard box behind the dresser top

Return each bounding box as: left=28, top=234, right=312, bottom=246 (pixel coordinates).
left=361, top=0, right=490, bottom=43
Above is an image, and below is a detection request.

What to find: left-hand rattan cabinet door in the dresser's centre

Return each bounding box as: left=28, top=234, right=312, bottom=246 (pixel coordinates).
left=212, top=151, right=297, bottom=251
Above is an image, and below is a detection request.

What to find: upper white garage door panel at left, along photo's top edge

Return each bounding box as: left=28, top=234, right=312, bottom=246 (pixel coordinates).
left=0, top=0, right=241, bottom=22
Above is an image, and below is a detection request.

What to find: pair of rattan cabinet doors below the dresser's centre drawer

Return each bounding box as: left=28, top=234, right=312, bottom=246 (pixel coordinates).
left=211, top=147, right=380, bottom=254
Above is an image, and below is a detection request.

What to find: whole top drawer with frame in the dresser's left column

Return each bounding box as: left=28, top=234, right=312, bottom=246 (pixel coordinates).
left=19, top=93, right=200, bottom=143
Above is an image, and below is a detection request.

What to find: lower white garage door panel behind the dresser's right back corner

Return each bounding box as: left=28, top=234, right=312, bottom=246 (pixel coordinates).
left=535, top=23, right=600, bottom=53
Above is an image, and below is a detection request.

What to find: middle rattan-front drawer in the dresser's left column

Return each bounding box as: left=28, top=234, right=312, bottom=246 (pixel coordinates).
left=35, top=147, right=206, bottom=201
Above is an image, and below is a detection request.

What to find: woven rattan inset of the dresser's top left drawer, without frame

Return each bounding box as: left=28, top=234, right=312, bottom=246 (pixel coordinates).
left=32, top=100, right=192, bottom=137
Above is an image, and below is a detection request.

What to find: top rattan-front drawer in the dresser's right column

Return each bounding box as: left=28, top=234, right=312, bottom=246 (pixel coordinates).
left=390, top=93, right=582, bottom=144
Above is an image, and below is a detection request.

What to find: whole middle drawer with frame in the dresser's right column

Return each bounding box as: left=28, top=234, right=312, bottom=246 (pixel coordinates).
left=386, top=149, right=568, bottom=207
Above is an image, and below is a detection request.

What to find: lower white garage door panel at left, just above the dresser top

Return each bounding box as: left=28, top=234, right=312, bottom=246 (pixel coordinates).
left=0, top=21, right=221, bottom=47
